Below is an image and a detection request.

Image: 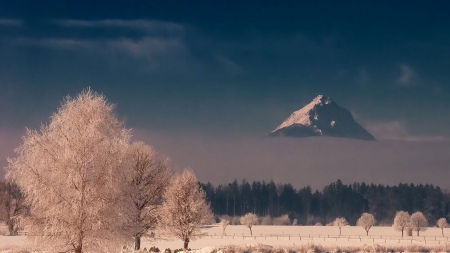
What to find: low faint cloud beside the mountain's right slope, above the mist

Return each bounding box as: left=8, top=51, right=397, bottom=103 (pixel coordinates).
left=366, top=121, right=449, bottom=142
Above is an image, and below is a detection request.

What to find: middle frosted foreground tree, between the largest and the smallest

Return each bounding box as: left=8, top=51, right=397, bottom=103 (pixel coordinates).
left=126, top=142, right=172, bottom=250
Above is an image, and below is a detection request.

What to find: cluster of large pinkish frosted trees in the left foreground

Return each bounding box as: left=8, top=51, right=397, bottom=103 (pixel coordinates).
left=2, top=89, right=212, bottom=253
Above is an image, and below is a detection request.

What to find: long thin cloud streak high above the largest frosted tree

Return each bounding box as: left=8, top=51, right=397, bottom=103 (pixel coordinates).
left=54, top=19, right=184, bottom=34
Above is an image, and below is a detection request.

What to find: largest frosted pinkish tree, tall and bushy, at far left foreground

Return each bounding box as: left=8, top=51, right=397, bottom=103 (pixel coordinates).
left=6, top=89, right=130, bottom=253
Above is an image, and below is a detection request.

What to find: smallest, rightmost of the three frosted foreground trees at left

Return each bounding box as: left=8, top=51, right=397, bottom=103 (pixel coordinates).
left=158, top=169, right=212, bottom=249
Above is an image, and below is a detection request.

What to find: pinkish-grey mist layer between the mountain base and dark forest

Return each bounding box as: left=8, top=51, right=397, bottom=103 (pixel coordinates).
left=133, top=130, right=450, bottom=188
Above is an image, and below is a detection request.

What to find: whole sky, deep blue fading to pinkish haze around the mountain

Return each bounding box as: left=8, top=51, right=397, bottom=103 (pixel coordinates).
left=0, top=0, right=450, bottom=187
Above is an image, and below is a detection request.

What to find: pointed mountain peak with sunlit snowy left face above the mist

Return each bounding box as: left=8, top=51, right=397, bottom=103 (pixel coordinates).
left=269, top=95, right=375, bottom=140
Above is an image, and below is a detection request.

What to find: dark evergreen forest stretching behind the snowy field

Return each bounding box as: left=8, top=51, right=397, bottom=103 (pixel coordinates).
left=200, top=180, right=450, bottom=226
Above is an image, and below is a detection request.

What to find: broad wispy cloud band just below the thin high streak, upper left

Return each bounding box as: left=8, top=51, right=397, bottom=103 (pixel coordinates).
left=0, top=36, right=204, bottom=75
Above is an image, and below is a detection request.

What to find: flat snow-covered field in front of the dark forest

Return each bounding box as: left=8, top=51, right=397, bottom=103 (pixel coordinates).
left=0, top=225, right=450, bottom=250
